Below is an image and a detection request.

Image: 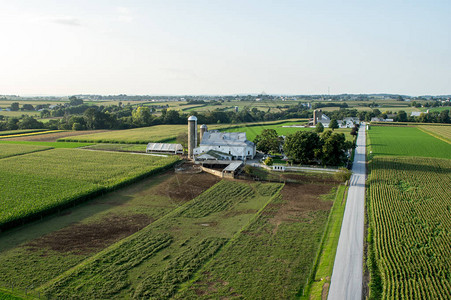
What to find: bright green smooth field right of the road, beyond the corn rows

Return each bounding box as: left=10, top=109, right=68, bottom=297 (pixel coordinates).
left=368, top=126, right=451, bottom=158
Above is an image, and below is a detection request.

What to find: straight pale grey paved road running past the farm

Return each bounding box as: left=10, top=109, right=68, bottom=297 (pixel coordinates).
left=328, top=125, right=366, bottom=300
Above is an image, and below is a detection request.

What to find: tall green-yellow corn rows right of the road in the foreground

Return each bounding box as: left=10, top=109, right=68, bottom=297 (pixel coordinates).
left=368, top=157, right=451, bottom=299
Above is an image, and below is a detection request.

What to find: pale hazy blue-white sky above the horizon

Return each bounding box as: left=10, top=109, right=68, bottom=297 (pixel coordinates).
left=0, top=0, right=451, bottom=96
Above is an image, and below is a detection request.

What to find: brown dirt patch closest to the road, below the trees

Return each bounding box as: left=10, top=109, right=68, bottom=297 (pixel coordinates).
left=268, top=183, right=333, bottom=234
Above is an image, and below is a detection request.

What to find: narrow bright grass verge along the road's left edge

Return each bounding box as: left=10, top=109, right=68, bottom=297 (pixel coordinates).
left=301, top=185, right=348, bottom=299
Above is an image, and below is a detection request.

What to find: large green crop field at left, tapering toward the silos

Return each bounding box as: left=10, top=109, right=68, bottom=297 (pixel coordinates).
left=0, top=149, right=178, bottom=226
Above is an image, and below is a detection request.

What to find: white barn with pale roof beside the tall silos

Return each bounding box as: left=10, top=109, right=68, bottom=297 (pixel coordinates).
left=193, top=130, right=256, bottom=160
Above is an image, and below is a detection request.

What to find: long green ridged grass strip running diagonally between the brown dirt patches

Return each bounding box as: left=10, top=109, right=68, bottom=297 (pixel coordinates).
left=38, top=181, right=282, bottom=299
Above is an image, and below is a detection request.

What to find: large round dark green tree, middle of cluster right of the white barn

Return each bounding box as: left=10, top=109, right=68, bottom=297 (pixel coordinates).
left=283, top=131, right=321, bottom=163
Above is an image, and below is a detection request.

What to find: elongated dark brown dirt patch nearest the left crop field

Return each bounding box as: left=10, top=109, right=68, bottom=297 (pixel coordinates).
left=25, top=214, right=152, bottom=254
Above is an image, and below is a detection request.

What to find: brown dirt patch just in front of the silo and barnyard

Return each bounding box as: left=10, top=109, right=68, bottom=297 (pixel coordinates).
left=156, top=173, right=220, bottom=203
